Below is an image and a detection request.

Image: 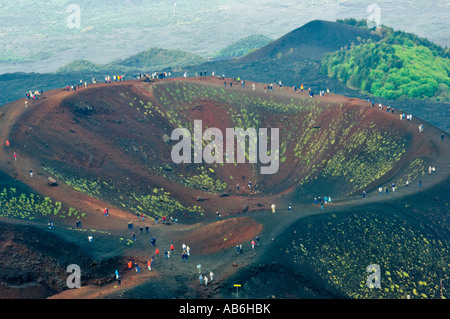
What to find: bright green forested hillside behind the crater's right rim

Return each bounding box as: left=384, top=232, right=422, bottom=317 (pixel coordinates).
left=322, top=20, right=450, bottom=102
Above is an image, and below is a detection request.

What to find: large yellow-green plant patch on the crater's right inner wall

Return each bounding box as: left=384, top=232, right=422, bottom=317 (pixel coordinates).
left=294, top=105, right=406, bottom=193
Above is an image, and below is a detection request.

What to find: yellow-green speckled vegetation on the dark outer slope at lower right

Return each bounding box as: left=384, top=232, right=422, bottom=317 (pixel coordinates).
left=287, top=212, right=450, bottom=299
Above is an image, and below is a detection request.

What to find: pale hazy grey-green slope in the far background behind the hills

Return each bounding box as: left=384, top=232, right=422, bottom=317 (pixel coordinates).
left=0, top=0, right=450, bottom=73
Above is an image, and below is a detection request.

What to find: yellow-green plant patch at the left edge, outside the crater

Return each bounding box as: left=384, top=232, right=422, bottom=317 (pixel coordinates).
left=0, top=188, right=85, bottom=220
